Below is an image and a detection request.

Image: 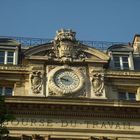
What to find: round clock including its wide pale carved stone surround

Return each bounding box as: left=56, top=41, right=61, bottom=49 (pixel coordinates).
left=49, top=67, right=84, bottom=95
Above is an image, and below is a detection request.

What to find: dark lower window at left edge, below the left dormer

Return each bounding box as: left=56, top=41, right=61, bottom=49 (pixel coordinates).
left=0, top=87, right=13, bottom=96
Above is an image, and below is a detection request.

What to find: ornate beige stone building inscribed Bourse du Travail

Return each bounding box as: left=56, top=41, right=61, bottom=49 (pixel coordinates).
left=0, top=30, right=140, bottom=140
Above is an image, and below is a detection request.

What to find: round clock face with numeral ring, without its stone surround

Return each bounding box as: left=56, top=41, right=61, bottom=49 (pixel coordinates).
left=54, top=70, right=80, bottom=91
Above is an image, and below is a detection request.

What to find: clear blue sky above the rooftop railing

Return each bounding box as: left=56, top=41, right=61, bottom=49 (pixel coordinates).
left=0, top=0, right=140, bottom=42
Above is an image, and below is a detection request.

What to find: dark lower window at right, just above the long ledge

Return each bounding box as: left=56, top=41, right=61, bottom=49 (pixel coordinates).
left=118, top=92, right=136, bottom=100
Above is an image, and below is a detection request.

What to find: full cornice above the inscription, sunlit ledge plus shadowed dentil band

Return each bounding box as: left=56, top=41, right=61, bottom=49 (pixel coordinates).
left=5, top=97, right=140, bottom=120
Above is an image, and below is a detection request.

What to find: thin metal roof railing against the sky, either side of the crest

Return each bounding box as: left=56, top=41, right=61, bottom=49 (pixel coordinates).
left=0, top=36, right=128, bottom=50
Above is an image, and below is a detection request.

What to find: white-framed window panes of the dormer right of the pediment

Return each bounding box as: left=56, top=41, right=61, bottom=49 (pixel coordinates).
left=113, top=55, right=130, bottom=70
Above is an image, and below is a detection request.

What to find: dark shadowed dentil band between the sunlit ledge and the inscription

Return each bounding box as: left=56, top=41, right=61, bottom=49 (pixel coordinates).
left=6, top=98, right=140, bottom=119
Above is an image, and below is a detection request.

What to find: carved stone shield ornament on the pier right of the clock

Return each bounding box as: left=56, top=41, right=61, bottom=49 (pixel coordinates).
left=92, top=74, right=104, bottom=96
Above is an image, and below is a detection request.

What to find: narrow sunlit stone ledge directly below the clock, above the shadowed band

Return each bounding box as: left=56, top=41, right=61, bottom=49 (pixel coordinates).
left=5, top=96, right=140, bottom=108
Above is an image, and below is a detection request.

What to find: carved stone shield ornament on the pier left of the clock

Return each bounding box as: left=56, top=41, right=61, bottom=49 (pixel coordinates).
left=31, top=71, right=42, bottom=94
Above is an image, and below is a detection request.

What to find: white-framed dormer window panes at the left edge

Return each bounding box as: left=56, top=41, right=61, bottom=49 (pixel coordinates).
left=0, top=50, right=15, bottom=64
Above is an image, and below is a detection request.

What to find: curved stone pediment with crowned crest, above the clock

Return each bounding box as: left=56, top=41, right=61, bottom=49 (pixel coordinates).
left=25, top=29, right=109, bottom=63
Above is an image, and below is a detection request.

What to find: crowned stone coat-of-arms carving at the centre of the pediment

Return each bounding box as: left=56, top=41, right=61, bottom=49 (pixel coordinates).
left=54, top=29, right=86, bottom=62
